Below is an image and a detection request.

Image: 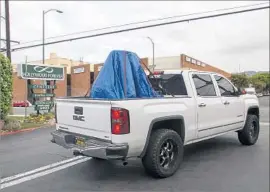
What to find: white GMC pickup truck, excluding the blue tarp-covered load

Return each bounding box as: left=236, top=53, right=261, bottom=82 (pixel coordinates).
left=52, top=70, right=260, bottom=178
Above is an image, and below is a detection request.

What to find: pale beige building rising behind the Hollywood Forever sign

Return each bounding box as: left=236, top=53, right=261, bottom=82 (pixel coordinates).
left=13, top=53, right=94, bottom=74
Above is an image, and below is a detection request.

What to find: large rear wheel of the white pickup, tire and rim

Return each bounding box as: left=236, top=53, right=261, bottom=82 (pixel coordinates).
left=142, top=129, right=184, bottom=178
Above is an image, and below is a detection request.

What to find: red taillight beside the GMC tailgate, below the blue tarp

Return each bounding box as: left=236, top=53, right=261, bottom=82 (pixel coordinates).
left=111, top=108, right=130, bottom=135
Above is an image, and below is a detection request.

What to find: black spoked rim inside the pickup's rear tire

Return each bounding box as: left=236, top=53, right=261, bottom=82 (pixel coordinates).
left=159, top=139, right=178, bottom=169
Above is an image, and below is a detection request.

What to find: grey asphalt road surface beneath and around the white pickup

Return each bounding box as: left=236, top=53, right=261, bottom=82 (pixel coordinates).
left=0, top=97, right=269, bottom=192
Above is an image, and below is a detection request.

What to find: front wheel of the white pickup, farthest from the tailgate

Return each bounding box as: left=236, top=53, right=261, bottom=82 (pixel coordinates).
left=238, top=115, right=260, bottom=145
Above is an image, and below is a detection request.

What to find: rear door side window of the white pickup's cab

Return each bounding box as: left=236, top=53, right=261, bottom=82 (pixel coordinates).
left=192, top=74, right=217, bottom=96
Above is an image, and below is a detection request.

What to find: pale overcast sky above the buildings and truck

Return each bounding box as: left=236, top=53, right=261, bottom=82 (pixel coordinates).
left=1, top=1, right=269, bottom=72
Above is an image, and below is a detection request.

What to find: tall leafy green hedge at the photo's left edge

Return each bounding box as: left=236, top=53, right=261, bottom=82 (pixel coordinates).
left=0, top=53, right=12, bottom=120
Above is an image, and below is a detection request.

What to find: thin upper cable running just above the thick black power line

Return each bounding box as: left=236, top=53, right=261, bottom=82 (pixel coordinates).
left=13, top=3, right=269, bottom=45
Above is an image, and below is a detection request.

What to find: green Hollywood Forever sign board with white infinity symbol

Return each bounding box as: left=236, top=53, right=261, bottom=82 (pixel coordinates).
left=17, top=64, right=64, bottom=80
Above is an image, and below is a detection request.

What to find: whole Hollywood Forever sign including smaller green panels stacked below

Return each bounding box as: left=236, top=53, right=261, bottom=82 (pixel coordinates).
left=17, top=64, right=64, bottom=114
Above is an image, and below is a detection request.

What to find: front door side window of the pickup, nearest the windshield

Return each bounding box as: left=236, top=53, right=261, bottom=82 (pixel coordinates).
left=215, top=75, right=235, bottom=97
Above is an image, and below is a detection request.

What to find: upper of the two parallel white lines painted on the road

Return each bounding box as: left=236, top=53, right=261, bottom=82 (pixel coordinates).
left=0, top=156, right=85, bottom=184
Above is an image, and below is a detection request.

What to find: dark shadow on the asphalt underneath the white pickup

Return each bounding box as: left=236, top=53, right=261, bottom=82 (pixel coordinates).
left=79, top=136, right=243, bottom=181
